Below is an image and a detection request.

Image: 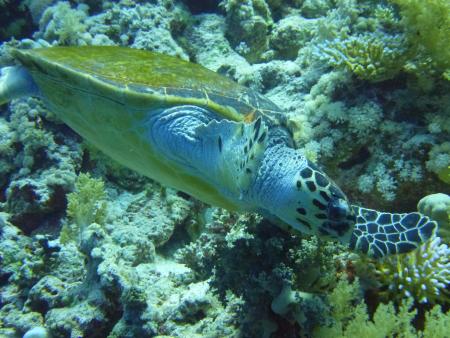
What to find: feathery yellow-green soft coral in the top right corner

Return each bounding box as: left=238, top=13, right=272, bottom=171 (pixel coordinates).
left=391, top=0, right=450, bottom=77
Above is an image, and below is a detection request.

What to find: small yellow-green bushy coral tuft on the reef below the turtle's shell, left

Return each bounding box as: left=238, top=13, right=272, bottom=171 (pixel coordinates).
left=60, top=174, right=106, bottom=242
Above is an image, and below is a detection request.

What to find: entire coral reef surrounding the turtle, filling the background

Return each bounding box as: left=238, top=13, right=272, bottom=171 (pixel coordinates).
left=0, top=0, right=450, bottom=338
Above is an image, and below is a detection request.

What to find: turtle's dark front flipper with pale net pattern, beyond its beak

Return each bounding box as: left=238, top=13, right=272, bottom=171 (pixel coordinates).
left=350, top=206, right=437, bottom=258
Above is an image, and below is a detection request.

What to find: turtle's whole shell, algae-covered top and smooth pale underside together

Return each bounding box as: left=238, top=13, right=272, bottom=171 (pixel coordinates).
left=12, top=46, right=283, bottom=210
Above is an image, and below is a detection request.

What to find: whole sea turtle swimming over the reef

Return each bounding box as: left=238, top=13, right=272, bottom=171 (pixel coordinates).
left=0, top=46, right=436, bottom=257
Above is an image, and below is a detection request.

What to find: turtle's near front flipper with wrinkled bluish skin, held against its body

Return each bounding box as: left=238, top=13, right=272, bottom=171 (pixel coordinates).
left=144, top=105, right=268, bottom=210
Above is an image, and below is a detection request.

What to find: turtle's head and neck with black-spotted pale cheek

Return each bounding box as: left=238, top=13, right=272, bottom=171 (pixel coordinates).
left=258, top=145, right=356, bottom=243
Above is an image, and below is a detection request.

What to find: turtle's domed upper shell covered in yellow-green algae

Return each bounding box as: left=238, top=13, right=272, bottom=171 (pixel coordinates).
left=13, top=46, right=284, bottom=124
